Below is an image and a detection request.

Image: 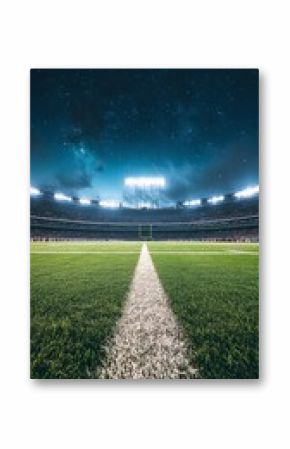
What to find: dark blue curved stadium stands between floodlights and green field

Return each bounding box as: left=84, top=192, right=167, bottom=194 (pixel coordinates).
left=31, top=195, right=259, bottom=241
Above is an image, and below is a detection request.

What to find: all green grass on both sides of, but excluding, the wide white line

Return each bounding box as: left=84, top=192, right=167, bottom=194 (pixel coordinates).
left=31, top=242, right=259, bottom=379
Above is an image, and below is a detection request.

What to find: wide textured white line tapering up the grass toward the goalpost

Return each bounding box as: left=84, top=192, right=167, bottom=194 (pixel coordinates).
left=97, top=244, right=198, bottom=379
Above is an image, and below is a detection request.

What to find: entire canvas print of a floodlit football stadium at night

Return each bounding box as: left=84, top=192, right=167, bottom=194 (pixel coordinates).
left=30, top=69, right=259, bottom=380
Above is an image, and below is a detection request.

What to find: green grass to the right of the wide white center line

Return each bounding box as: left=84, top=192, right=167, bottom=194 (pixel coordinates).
left=149, top=243, right=259, bottom=379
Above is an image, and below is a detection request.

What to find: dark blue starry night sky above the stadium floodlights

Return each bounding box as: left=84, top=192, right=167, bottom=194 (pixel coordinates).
left=31, top=69, right=258, bottom=201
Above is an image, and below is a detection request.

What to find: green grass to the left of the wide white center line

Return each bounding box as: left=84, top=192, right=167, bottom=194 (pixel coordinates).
left=31, top=243, right=140, bottom=379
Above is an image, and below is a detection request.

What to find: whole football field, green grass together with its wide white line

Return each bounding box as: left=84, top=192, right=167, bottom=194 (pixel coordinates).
left=31, top=242, right=259, bottom=379
